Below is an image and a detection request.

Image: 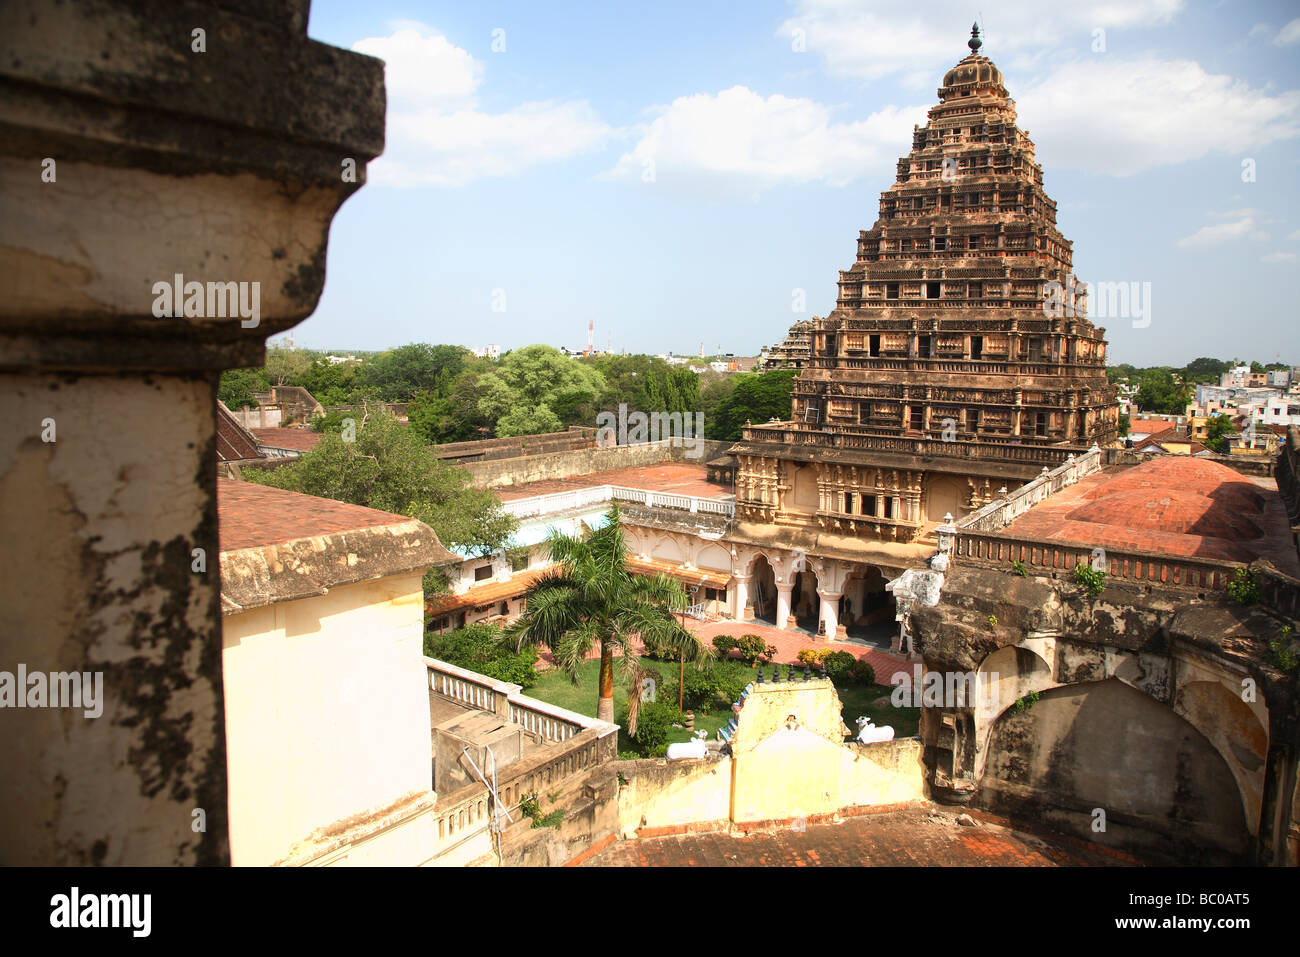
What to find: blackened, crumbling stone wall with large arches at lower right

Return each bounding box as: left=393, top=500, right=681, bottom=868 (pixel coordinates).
left=911, top=566, right=1297, bottom=862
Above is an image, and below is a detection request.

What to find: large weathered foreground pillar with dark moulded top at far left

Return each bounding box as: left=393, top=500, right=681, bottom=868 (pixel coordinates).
left=0, top=0, right=385, bottom=866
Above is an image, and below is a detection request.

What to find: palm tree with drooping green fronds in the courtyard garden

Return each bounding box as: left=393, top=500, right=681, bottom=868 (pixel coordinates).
left=506, top=503, right=711, bottom=735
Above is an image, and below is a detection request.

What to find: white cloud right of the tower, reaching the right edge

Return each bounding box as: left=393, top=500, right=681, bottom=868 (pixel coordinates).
left=1018, top=56, right=1300, bottom=176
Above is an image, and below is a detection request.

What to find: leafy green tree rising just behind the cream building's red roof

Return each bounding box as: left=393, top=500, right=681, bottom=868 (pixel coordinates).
left=244, top=407, right=517, bottom=581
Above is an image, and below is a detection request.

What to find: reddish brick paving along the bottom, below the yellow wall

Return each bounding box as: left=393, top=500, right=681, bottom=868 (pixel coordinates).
left=582, top=804, right=1138, bottom=867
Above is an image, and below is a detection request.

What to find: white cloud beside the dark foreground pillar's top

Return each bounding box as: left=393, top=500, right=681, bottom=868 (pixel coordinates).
left=352, top=23, right=612, bottom=186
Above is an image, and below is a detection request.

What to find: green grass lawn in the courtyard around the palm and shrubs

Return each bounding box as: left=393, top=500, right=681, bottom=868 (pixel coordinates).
left=524, top=659, right=920, bottom=758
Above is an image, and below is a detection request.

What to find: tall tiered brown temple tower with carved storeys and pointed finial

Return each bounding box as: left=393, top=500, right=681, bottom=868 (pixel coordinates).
left=732, top=27, right=1119, bottom=551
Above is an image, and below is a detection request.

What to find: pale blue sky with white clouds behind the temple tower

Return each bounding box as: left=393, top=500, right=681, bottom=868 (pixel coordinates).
left=295, top=0, right=1300, bottom=364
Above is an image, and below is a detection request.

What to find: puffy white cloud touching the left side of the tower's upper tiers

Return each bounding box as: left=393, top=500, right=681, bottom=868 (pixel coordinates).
left=605, top=86, right=926, bottom=198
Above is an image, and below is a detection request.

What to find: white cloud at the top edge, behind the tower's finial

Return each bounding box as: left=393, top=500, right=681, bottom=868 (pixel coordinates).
left=776, top=0, right=1183, bottom=86
